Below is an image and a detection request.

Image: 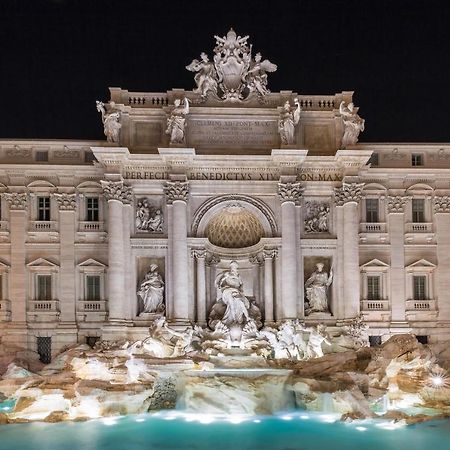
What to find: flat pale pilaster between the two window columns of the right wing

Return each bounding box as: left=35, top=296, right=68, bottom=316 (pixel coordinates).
left=387, top=195, right=408, bottom=324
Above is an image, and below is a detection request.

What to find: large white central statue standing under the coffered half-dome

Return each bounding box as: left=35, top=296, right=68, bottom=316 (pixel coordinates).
left=208, top=261, right=261, bottom=329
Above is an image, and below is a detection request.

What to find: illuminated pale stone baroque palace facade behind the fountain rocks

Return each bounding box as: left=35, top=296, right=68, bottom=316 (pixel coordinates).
left=0, top=30, right=450, bottom=361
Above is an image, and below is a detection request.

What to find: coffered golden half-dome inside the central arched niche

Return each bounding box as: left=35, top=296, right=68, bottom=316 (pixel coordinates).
left=205, top=205, right=265, bottom=248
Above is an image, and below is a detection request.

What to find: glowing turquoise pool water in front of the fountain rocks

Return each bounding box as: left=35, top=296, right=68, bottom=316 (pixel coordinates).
left=0, top=412, right=450, bottom=450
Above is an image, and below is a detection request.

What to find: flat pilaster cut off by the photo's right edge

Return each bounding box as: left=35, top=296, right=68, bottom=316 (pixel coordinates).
left=433, top=196, right=450, bottom=322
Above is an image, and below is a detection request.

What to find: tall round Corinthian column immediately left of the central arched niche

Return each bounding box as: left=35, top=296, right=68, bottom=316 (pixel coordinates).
left=164, top=181, right=189, bottom=322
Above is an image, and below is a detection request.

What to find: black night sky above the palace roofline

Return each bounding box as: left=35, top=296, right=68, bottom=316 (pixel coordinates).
left=0, top=0, right=450, bottom=142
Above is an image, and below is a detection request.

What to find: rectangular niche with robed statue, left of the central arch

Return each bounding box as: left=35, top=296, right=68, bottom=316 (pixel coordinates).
left=136, top=258, right=165, bottom=316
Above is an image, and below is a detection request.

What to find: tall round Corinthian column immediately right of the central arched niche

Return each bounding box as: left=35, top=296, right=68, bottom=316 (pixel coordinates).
left=278, top=183, right=303, bottom=320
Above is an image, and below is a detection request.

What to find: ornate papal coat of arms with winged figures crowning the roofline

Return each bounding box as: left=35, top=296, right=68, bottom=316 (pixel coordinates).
left=186, top=29, right=277, bottom=102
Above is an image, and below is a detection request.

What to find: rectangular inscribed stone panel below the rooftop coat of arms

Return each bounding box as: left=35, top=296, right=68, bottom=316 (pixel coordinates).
left=187, top=119, right=279, bottom=148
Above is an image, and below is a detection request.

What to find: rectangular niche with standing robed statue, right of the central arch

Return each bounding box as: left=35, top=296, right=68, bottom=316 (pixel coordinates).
left=304, top=256, right=333, bottom=316
